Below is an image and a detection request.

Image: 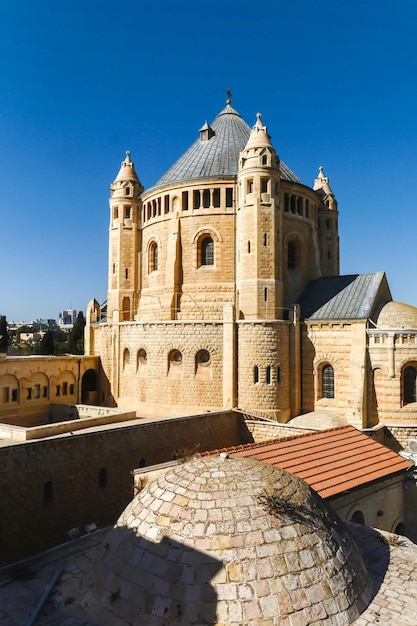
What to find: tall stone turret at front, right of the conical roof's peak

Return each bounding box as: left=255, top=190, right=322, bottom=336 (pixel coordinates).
left=236, top=113, right=282, bottom=319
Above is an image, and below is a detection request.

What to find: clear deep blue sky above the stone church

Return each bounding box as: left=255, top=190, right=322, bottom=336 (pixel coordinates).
left=0, top=0, right=417, bottom=321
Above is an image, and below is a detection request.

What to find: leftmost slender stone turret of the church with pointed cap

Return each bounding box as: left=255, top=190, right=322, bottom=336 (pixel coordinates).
left=107, top=150, right=143, bottom=321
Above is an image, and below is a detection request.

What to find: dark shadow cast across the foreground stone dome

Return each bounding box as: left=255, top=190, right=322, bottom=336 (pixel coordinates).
left=81, top=527, right=222, bottom=626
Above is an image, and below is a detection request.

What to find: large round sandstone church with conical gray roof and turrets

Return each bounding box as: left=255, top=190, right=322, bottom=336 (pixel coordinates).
left=85, top=100, right=417, bottom=428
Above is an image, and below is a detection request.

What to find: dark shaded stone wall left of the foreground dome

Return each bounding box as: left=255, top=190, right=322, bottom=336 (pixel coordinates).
left=0, top=412, right=252, bottom=565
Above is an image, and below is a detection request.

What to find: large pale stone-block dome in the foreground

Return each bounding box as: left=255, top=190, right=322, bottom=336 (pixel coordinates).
left=83, top=457, right=372, bottom=626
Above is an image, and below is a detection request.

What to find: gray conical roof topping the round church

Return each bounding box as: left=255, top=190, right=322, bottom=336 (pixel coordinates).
left=154, top=104, right=303, bottom=187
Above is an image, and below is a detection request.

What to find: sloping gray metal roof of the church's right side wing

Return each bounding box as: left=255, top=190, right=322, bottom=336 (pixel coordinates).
left=298, top=272, right=385, bottom=321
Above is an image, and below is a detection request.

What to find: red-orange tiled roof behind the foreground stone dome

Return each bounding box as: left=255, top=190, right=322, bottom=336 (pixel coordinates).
left=198, top=426, right=413, bottom=498
